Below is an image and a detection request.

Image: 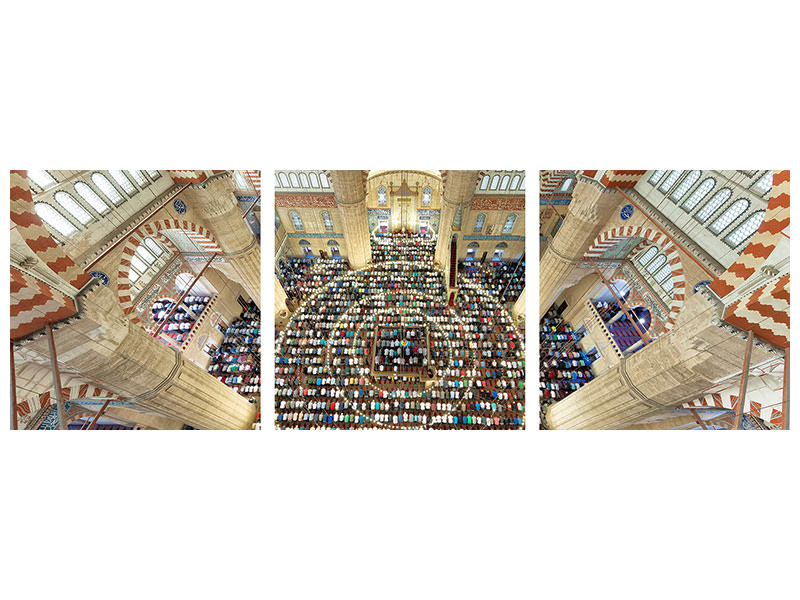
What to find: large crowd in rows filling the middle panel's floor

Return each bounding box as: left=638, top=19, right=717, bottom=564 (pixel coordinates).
left=275, top=234, right=525, bottom=429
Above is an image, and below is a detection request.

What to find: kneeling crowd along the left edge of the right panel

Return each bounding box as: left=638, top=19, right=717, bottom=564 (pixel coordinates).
left=539, top=306, right=597, bottom=424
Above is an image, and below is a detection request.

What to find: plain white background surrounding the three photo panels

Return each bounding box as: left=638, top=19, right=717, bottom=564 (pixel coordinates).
left=0, top=0, right=798, bottom=599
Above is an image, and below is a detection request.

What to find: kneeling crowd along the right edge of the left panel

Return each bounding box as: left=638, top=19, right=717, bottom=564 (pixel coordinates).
left=208, top=301, right=261, bottom=404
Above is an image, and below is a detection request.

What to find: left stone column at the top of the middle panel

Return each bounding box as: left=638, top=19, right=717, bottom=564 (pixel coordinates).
left=331, top=171, right=372, bottom=269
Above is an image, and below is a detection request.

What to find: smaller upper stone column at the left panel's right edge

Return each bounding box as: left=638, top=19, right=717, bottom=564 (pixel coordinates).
left=187, top=177, right=261, bottom=307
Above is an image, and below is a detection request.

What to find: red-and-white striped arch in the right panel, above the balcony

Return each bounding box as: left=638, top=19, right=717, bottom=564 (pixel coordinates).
left=584, top=225, right=686, bottom=330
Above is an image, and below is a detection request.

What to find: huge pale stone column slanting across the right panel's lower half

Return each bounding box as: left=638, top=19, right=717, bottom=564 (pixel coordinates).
left=545, top=293, right=773, bottom=429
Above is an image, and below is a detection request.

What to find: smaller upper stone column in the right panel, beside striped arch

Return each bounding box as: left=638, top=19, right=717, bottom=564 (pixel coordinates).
left=539, top=177, right=619, bottom=319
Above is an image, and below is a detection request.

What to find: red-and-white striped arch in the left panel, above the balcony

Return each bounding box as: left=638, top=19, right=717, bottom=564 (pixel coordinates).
left=117, top=219, right=222, bottom=326
